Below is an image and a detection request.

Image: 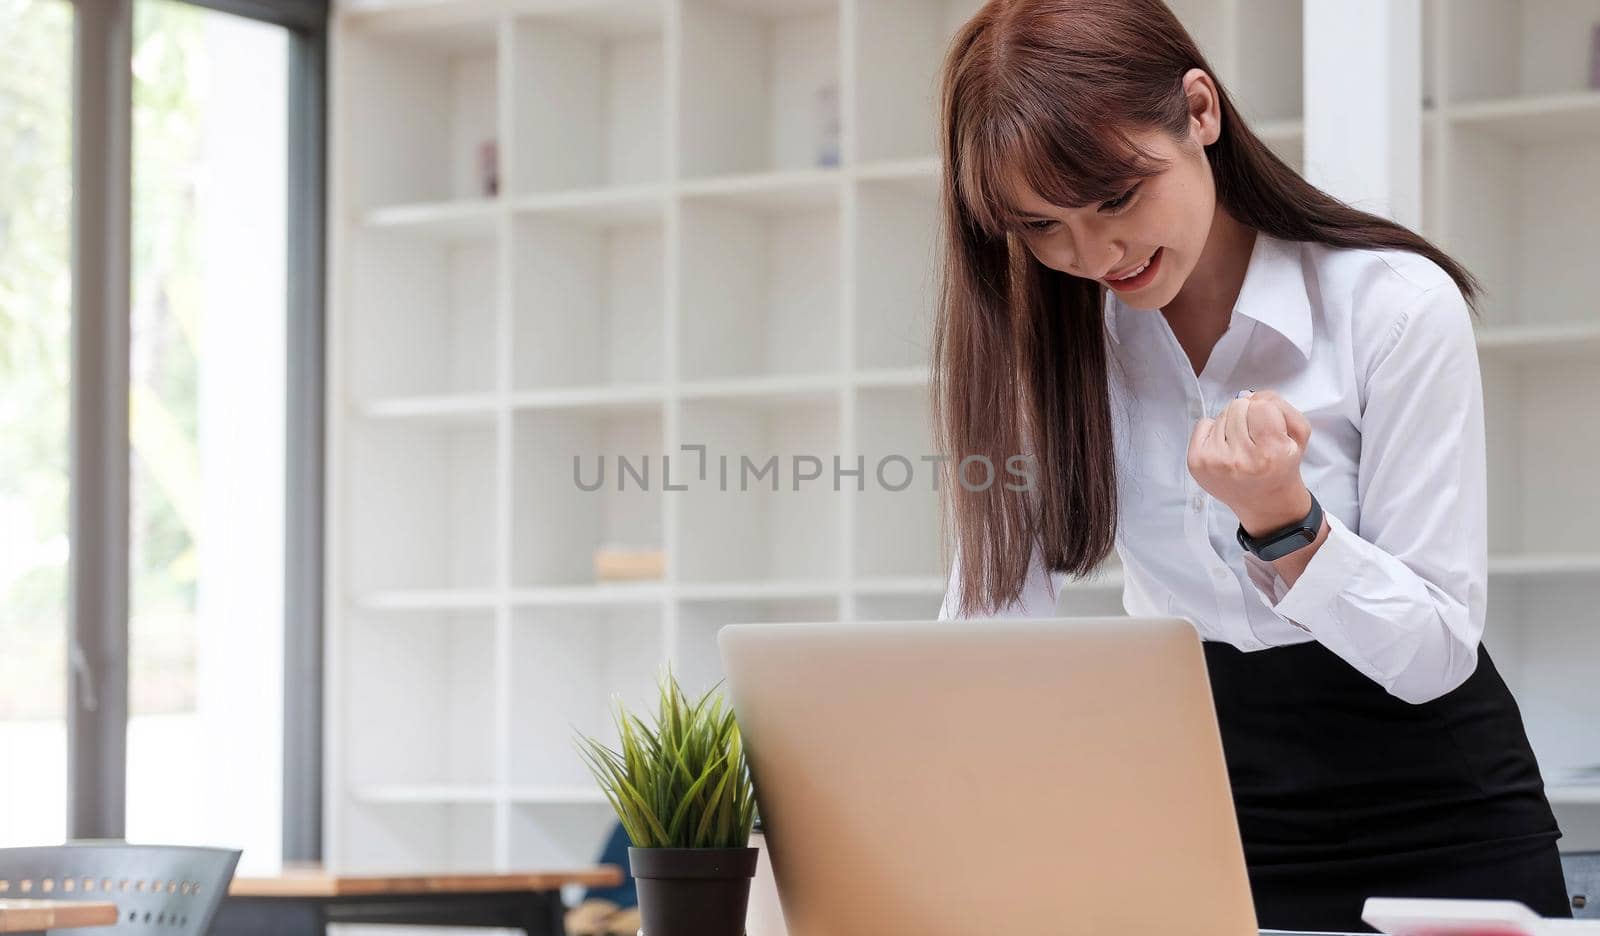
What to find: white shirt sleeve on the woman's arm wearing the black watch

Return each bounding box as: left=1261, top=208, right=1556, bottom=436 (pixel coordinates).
left=1245, top=283, right=1488, bottom=704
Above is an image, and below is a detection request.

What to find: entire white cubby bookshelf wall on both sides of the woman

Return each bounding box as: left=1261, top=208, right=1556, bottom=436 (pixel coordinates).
left=326, top=0, right=1600, bottom=889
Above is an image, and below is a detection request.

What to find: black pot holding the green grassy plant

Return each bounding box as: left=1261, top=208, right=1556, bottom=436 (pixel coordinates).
left=627, top=848, right=760, bottom=936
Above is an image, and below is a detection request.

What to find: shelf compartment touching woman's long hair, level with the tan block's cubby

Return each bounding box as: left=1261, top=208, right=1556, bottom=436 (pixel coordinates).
left=854, top=389, right=940, bottom=578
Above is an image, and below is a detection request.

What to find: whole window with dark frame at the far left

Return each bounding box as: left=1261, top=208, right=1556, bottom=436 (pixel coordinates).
left=0, top=0, right=328, bottom=870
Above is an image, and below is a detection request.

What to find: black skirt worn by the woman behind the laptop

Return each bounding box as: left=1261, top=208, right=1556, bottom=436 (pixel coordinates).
left=1205, top=642, right=1571, bottom=933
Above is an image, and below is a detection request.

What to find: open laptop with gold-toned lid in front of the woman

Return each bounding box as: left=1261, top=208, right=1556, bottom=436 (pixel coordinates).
left=717, top=618, right=1344, bottom=936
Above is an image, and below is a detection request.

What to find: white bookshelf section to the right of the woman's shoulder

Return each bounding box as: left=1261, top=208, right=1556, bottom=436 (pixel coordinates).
left=1422, top=0, right=1600, bottom=848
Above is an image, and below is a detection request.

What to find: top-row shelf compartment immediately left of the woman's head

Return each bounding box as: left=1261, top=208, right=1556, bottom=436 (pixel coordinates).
left=853, top=0, right=981, bottom=160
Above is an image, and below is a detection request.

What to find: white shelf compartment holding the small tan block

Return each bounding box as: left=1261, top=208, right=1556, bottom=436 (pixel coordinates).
left=512, top=403, right=662, bottom=587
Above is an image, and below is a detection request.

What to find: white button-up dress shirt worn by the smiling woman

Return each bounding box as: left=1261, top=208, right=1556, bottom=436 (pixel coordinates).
left=939, top=232, right=1488, bottom=702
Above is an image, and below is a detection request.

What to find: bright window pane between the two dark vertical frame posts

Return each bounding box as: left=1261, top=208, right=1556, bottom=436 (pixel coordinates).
left=126, top=0, right=288, bottom=870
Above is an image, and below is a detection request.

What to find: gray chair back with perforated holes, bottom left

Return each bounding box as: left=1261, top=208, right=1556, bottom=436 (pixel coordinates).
left=0, top=842, right=240, bottom=936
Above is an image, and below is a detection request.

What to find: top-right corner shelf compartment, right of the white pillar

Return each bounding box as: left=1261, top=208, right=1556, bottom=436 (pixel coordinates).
left=1438, top=0, right=1600, bottom=104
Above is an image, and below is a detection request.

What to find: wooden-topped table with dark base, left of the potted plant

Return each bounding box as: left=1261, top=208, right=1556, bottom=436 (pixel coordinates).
left=211, top=864, right=622, bottom=936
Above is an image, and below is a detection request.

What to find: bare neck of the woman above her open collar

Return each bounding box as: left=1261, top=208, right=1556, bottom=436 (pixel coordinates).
left=1162, top=205, right=1256, bottom=374
